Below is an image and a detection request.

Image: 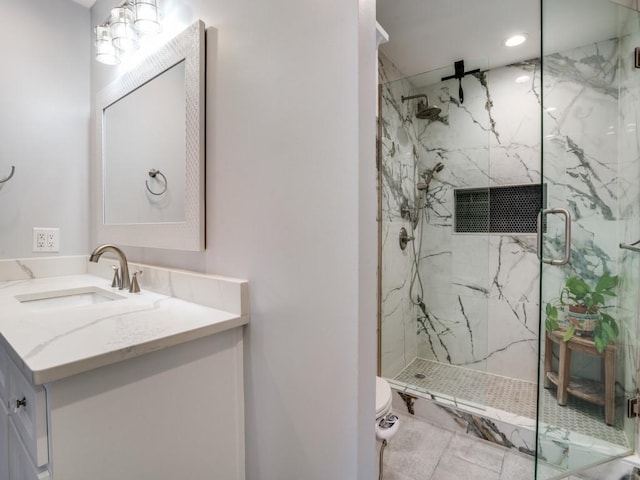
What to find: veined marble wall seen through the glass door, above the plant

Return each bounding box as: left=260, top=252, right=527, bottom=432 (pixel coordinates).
left=543, top=40, right=619, bottom=304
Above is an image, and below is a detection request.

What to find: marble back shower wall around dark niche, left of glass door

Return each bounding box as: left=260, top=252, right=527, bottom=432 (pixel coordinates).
left=410, top=61, right=540, bottom=381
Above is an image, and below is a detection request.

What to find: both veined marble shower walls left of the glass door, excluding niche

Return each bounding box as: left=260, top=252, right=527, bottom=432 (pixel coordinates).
left=381, top=53, right=540, bottom=380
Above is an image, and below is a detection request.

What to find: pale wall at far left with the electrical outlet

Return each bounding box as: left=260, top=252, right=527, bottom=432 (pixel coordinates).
left=0, top=0, right=90, bottom=258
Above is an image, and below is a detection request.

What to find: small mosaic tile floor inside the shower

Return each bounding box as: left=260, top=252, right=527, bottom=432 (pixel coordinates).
left=394, top=358, right=628, bottom=446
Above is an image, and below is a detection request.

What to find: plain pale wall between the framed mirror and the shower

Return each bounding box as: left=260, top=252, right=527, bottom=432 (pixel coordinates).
left=91, top=0, right=376, bottom=480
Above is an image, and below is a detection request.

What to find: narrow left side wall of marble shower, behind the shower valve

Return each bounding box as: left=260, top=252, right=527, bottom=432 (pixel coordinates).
left=378, top=54, right=418, bottom=377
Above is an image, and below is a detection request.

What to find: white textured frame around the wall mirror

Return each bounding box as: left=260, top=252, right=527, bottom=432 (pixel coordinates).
left=96, top=20, right=205, bottom=251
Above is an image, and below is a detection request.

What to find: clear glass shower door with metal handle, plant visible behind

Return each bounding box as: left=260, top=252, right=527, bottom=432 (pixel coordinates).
left=536, top=0, right=640, bottom=479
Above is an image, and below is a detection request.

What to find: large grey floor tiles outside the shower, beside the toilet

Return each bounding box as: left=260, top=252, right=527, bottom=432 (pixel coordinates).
left=377, top=414, right=630, bottom=480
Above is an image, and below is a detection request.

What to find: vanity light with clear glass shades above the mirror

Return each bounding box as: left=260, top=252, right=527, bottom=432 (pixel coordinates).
left=95, top=0, right=162, bottom=65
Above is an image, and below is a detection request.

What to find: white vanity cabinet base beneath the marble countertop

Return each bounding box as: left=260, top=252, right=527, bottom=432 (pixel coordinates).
left=0, top=327, right=244, bottom=480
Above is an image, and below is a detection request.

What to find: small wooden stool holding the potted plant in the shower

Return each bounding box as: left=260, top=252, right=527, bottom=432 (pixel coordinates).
left=544, top=330, right=616, bottom=425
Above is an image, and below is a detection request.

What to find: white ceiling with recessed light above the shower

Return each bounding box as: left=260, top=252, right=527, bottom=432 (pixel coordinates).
left=377, top=0, right=622, bottom=83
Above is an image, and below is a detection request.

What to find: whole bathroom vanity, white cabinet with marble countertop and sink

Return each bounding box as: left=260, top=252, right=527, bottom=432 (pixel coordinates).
left=0, top=257, right=248, bottom=480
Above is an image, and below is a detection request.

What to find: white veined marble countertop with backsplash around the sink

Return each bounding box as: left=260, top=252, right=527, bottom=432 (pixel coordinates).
left=0, top=256, right=249, bottom=385
